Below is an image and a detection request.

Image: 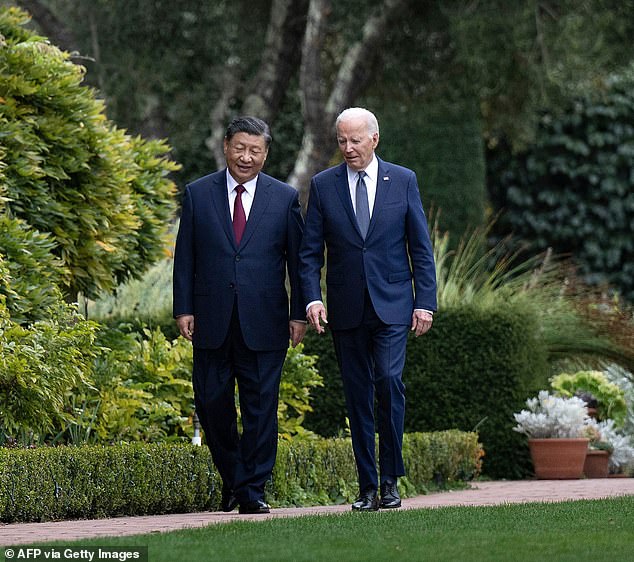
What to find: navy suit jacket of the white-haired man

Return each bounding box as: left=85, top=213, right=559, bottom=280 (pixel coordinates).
left=300, top=159, right=436, bottom=330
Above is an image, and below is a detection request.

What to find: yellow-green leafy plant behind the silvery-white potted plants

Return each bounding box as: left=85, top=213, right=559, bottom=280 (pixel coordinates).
left=550, top=371, right=627, bottom=427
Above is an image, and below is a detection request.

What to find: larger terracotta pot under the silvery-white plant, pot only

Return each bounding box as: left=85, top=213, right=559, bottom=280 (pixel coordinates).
left=528, top=438, right=590, bottom=480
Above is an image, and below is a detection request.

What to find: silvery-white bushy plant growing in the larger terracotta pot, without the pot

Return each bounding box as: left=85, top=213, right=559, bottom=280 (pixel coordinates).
left=513, top=390, right=589, bottom=439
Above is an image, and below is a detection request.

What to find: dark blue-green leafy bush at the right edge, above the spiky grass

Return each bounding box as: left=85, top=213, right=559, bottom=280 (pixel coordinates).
left=489, top=63, right=634, bottom=300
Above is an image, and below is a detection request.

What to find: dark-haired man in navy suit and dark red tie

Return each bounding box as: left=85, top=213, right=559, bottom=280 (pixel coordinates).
left=174, top=117, right=306, bottom=513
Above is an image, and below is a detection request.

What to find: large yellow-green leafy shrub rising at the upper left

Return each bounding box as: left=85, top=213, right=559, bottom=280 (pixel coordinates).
left=0, top=9, right=177, bottom=296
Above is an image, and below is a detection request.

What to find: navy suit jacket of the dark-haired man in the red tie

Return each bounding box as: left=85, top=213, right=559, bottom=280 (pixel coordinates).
left=174, top=170, right=306, bottom=351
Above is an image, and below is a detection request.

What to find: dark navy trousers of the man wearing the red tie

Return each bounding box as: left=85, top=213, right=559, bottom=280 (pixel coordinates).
left=193, top=307, right=286, bottom=503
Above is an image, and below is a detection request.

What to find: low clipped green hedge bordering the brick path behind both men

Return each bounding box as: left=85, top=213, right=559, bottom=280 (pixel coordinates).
left=0, top=431, right=482, bottom=523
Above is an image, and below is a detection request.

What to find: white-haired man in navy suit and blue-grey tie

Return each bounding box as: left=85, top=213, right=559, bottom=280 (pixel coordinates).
left=300, top=108, right=436, bottom=511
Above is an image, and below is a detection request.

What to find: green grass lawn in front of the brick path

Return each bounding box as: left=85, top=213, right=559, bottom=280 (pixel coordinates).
left=35, top=497, right=634, bottom=562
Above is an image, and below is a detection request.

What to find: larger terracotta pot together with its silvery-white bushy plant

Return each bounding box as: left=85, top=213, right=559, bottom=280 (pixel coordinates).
left=513, top=390, right=590, bottom=479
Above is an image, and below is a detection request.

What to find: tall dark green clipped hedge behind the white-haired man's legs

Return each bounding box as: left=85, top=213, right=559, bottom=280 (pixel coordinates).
left=304, top=305, right=549, bottom=478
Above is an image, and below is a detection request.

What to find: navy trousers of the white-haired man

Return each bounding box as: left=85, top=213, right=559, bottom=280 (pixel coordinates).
left=333, top=293, right=409, bottom=491
